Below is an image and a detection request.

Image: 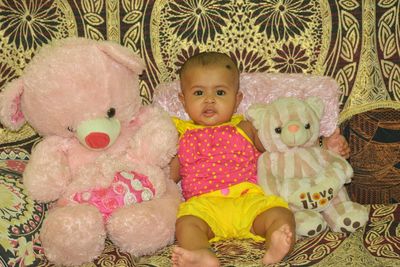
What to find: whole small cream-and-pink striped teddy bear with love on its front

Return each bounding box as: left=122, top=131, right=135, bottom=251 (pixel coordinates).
left=246, top=97, right=368, bottom=236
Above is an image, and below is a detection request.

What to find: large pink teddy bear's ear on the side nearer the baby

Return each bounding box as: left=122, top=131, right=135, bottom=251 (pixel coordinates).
left=97, top=41, right=145, bottom=74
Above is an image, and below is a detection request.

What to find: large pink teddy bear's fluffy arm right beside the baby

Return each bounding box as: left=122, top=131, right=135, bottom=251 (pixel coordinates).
left=128, top=105, right=178, bottom=168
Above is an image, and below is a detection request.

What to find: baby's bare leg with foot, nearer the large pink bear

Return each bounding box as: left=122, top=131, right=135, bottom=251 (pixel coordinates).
left=172, top=215, right=219, bottom=267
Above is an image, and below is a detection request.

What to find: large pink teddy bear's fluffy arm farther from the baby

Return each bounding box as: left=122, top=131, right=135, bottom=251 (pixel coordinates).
left=23, top=136, right=71, bottom=202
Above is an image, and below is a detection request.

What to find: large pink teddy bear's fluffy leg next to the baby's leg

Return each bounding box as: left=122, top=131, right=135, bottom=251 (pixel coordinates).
left=107, top=180, right=181, bottom=256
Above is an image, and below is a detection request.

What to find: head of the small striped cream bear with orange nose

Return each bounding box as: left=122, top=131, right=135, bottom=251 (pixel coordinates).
left=246, top=97, right=324, bottom=152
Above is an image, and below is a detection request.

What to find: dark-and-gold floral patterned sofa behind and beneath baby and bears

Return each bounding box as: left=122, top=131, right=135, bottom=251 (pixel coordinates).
left=0, top=0, right=400, bottom=267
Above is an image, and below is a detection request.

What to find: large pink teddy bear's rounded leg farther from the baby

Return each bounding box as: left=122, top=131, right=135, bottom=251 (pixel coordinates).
left=40, top=204, right=106, bottom=266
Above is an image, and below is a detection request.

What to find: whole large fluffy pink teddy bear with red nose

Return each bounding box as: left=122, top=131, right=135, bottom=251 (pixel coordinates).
left=0, top=38, right=181, bottom=265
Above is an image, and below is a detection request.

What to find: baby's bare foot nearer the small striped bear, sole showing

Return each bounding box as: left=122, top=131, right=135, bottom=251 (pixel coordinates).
left=262, top=224, right=293, bottom=264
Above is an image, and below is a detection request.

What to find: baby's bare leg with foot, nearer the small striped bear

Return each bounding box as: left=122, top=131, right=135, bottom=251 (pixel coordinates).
left=252, top=207, right=296, bottom=264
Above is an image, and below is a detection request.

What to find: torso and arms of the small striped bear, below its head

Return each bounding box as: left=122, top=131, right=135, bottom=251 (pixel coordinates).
left=257, top=147, right=352, bottom=211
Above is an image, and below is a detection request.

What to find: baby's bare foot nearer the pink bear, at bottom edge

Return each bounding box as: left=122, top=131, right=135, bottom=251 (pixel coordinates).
left=172, top=247, right=219, bottom=267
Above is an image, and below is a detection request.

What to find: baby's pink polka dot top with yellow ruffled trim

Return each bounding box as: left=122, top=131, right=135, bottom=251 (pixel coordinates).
left=173, top=115, right=260, bottom=200
